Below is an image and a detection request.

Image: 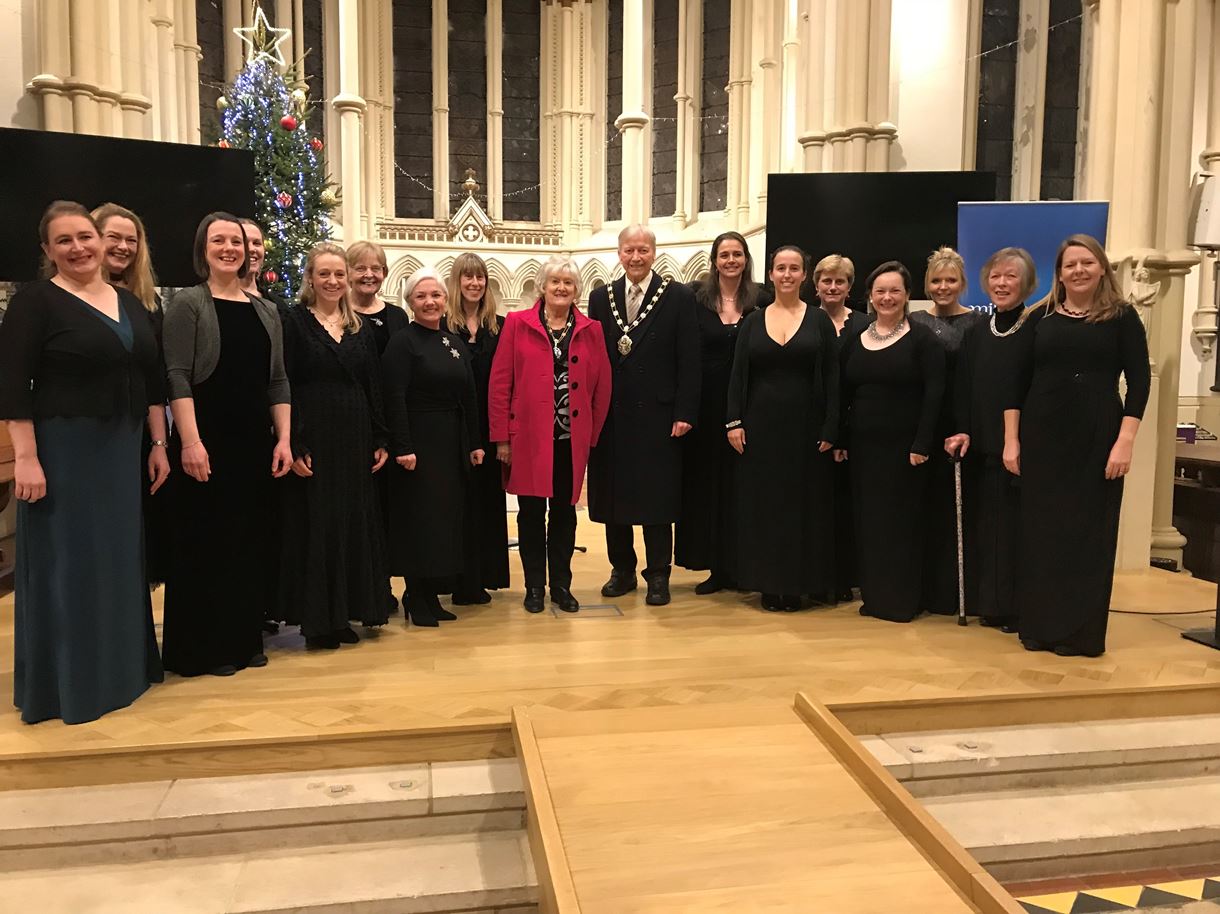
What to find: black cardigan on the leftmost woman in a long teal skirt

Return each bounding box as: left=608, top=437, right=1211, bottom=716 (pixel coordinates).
left=0, top=279, right=165, bottom=420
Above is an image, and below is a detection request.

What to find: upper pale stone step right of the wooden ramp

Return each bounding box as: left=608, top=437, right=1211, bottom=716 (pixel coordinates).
left=863, top=715, right=1220, bottom=797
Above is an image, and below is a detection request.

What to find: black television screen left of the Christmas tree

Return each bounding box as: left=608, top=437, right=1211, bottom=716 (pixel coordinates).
left=0, top=127, right=254, bottom=287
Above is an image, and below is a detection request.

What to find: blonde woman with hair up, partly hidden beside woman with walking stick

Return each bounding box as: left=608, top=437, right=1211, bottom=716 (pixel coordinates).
left=910, top=248, right=987, bottom=615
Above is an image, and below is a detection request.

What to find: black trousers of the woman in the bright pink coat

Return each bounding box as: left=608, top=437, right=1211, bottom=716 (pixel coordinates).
left=517, top=438, right=576, bottom=588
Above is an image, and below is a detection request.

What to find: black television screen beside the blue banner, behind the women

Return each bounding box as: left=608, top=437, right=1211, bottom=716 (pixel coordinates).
left=766, top=171, right=996, bottom=309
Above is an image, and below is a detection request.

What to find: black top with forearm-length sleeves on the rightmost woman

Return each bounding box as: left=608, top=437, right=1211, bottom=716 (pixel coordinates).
left=1008, top=306, right=1152, bottom=419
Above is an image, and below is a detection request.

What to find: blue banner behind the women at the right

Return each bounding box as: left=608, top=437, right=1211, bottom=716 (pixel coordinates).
left=958, top=200, right=1110, bottom=309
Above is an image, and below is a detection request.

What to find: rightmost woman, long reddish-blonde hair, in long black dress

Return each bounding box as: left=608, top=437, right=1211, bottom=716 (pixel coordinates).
left=1004, top=234, right=1152, bottom=657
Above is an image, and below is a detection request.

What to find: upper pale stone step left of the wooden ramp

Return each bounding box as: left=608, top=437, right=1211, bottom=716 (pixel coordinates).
left=0, top=759, right=525, bottom=871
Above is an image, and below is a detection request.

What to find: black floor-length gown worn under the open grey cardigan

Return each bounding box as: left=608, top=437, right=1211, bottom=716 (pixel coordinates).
left=162, top=299, right=278, bottom=676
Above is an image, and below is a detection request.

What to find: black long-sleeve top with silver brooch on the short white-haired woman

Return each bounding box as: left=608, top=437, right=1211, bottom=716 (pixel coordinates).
left=382, top=321, right=482, bottom=458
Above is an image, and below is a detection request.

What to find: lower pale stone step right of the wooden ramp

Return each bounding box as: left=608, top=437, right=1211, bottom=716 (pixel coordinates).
left=924, top=776, right=1220, bottom=881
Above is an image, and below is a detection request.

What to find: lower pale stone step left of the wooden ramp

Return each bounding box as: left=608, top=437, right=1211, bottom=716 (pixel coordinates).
left=0, top=830, right=538, bottom=914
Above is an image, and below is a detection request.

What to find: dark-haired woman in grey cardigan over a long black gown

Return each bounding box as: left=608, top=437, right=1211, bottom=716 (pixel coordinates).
left=163, top=212, right=293, bottom=676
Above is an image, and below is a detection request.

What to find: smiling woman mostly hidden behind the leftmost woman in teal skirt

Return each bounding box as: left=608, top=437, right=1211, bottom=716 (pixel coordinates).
left=93, top=203, right=171, bottom=587
